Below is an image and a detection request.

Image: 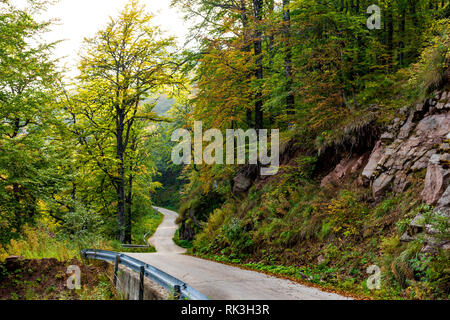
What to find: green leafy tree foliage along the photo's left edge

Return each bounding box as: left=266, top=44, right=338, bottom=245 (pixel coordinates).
left=0, top=1, right=70, bottom=244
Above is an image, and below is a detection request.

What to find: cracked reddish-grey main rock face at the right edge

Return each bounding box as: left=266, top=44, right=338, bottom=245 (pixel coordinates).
left=362, top=92, right=450, bottom=201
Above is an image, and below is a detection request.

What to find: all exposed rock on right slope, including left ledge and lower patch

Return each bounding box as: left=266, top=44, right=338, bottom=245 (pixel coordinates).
left=322, top=91, right=450, bottom=252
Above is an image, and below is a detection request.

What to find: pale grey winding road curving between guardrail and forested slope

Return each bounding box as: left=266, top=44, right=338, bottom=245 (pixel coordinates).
left=129, top=207, right=348, bottom=300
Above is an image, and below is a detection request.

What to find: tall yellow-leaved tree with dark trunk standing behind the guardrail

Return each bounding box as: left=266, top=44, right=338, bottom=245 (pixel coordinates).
left=74, top=1, right=180, bottom=242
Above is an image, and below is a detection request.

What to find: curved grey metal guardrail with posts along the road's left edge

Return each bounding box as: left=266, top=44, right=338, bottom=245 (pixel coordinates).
left=81, top=249, right=209, bottom=300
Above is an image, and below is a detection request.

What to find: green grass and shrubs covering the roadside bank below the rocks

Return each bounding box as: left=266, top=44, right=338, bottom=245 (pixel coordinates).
left=192, top=160, right=448, bottom=299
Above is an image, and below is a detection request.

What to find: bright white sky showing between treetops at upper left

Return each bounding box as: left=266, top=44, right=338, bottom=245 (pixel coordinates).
left=10, top=0, right=187, bottom=75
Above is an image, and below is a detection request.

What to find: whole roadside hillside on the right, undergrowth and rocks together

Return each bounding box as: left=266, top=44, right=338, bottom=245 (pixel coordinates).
left=182, top=86, right=450, bottom=299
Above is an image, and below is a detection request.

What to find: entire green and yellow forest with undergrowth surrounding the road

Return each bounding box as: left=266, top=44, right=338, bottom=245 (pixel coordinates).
left=0, top=0, right=450, bottom=299
